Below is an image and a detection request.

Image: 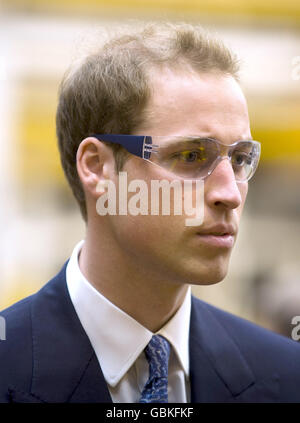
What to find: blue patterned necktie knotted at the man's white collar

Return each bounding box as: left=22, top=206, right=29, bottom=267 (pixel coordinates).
left=140, top=335, right=170, bottom=403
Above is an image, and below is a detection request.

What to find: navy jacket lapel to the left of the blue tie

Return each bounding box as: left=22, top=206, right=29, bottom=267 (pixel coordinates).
left=11, top=264, right=112, bottom=403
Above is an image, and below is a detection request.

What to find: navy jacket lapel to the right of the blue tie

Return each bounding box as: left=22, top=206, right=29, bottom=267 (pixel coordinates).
left=190, top=297, right=278, bottom=402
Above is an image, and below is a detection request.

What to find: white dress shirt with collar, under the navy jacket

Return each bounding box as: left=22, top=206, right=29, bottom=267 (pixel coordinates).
left=66, top=240, right=191, bottom=403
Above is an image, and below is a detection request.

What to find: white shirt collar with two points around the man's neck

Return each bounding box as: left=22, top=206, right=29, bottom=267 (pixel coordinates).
left=66, top=240, right=191, bottom=386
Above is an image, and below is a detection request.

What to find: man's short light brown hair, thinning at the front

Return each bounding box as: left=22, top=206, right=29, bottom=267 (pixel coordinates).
left=56, top=23, right=239, bottom=220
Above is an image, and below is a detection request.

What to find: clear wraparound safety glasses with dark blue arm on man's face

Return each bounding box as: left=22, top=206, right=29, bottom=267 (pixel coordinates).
left=92, top=134, right=260, bottom=182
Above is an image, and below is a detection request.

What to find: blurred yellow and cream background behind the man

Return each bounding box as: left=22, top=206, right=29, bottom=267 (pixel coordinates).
left=0, top=0, right=300, bottom=337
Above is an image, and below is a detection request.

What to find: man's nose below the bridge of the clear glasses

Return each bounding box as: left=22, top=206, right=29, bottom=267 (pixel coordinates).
left=205, top=159, right=247, bottom=209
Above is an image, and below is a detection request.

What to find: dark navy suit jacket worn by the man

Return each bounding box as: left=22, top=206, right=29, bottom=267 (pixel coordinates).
left=0, top=264, right=300, bottom=403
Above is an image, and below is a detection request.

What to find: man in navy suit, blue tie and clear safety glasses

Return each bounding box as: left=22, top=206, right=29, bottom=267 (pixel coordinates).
left=0, top=24, right=300, bottom=402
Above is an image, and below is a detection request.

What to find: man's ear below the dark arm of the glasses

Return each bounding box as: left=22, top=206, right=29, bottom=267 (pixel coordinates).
left=76, top=137, right=116, bottom=199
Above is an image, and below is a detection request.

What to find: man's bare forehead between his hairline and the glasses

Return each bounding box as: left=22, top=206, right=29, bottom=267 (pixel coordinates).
left=139, top=69, right=251, bottom=142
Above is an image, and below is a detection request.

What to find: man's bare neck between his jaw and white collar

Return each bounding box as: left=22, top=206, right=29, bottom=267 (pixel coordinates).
left=79, top=224, right=188, bottom=332
